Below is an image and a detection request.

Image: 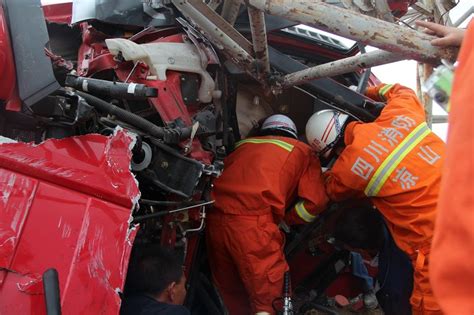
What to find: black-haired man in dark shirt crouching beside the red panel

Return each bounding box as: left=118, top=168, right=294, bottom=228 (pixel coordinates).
left=120, top=248, right=190, bottom=315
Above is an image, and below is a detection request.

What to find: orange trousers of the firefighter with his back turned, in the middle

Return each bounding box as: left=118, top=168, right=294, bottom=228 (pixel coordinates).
left=206, top=213, right=288, bottom=315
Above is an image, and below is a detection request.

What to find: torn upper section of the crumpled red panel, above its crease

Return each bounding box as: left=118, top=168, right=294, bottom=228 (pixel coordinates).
left=0, top=131, right=139, bottom=208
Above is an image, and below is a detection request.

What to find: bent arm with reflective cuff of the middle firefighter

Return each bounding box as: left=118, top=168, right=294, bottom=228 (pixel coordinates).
left=285, top=156, right=329, bottom=225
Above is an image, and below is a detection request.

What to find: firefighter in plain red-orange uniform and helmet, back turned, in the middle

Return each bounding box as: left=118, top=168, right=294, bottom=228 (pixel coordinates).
left=206, top=115, right=328, bottom=315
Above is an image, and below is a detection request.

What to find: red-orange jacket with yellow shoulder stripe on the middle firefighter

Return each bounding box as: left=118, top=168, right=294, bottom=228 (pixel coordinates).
left=212, top=136, right=328, bottom=224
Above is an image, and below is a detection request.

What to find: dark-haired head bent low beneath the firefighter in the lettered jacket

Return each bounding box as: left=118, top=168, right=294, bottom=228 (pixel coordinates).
left=334, top=203, right=384, bottom=251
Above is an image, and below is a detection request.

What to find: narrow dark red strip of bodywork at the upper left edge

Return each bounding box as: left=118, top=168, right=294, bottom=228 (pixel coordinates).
left=0, top=2, right=21, bottom=112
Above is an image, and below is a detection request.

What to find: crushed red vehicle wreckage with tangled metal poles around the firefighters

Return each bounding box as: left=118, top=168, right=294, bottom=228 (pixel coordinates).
left=0, top=0, right=455, bottom=314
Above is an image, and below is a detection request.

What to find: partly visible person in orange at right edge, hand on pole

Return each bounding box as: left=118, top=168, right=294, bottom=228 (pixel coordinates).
left=418, top=20, right=474, bottom=315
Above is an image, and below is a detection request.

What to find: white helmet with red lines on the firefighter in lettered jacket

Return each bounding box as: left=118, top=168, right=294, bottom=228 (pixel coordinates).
left=306, top=109, right=348, bottom=157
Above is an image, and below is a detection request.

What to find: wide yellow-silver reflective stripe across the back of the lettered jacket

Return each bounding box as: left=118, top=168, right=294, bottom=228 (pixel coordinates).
left=364, top=122, right=431, bottom=197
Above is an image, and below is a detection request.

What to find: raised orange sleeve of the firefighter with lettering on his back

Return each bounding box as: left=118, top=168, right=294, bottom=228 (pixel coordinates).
left=365, top=84, right=424, bottom=112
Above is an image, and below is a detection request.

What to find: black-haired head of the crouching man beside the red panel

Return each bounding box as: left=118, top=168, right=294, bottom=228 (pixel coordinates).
left=126, top=247, right=186, bottom=304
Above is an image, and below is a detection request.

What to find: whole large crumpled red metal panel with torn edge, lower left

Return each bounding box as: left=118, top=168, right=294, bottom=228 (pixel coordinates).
left=0, top=130, right=139, bottom=314
